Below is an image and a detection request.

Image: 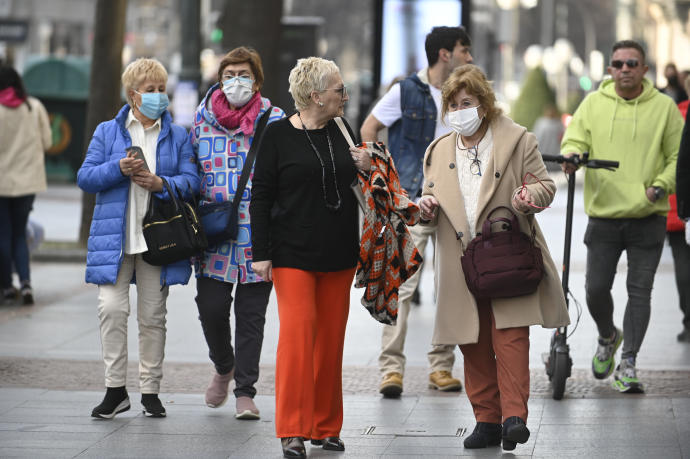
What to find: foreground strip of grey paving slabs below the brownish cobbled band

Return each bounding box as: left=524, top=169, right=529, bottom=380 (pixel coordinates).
left=0, top=388, right=690, bottom=458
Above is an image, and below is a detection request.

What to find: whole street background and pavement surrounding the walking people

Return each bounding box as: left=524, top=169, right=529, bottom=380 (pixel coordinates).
left=0, top=0, right=690, bottom=458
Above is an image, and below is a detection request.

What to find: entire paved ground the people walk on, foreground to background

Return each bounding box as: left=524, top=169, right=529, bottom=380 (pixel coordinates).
left=0, top=187, right=690, bottom=458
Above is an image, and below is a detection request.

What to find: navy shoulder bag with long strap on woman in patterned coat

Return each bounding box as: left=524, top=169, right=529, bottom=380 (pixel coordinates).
left=199, top=107, right=273, bottom=245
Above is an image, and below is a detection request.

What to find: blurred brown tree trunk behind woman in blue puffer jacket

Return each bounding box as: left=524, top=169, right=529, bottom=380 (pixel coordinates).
left=79, top=0, right=127, bottom=246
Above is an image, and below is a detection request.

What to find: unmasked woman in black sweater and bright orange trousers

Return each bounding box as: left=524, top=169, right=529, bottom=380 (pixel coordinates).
left=249, top=57, right=371, bottom=457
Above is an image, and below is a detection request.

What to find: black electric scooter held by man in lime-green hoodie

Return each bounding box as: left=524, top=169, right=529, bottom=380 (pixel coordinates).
left=542, top=152, right=619, bottom=400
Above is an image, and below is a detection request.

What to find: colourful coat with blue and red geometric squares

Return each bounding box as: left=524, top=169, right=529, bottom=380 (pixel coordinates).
left=190, top=84, right=285, bottom=284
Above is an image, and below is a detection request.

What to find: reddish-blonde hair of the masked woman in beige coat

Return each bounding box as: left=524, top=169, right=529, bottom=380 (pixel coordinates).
left=441, top=64, right=501, bottom=123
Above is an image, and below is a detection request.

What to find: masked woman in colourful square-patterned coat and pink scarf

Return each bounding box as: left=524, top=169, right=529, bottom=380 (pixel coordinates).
left=190, top=47, right=285, bottom=419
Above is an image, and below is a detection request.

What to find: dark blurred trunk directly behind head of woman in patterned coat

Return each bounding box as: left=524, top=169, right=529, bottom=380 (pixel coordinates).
left=218, top=0, right=283, bottom=100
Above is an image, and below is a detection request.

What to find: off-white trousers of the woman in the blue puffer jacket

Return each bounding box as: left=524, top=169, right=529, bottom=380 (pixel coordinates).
left=98, top=254, right=168, bottom=394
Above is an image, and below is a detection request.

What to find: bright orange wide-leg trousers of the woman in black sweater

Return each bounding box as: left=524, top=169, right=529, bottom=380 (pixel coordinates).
left=273, top=268, right=355, bottom=439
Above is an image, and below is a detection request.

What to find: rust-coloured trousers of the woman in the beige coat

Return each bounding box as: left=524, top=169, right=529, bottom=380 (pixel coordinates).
left=460, top=300, right=529, bottom=424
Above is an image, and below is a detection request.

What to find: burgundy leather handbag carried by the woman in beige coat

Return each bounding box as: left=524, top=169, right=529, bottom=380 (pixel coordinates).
left=460, top=206, right=544, bottom=298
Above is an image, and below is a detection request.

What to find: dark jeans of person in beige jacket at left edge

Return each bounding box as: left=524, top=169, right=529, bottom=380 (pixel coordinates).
left=0, top=194, right=36, bottom=289
